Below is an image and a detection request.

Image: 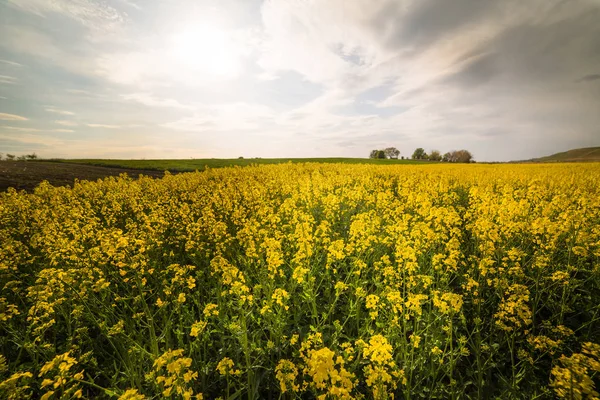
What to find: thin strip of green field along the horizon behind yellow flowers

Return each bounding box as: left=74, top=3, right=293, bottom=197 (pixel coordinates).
left=51, top=157, right=427, bottom=172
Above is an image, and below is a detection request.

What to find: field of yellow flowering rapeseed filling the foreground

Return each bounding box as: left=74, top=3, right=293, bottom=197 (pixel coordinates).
left=0, top=164, right=600, bottom=399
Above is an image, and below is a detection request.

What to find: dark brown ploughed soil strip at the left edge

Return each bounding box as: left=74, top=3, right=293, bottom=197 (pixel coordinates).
left=0, top=161, right=169, bottom=192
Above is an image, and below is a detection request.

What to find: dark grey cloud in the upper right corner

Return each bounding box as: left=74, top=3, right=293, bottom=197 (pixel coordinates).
left=369, top=0, right=600, bottom=87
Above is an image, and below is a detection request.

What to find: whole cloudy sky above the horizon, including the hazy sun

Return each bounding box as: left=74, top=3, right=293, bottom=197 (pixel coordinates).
left=0, top=0, right=600, bottom=161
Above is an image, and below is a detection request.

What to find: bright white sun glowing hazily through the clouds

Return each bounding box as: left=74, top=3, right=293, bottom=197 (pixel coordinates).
left=170, top=24, right=241, bottom=78
